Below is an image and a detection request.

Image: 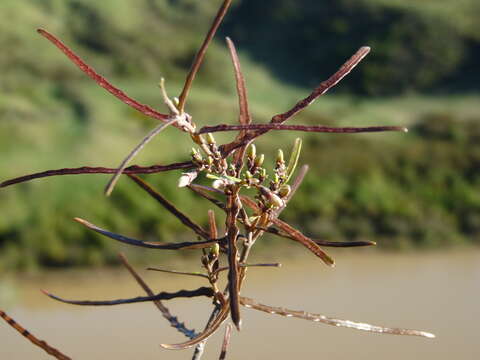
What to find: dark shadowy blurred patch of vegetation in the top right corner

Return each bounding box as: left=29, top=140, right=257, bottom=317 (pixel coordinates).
left=225, top=0, right=480, bottom=95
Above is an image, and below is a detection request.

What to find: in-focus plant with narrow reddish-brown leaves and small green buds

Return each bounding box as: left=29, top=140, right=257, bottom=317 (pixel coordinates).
left=0, top=0, right=434, bottom=359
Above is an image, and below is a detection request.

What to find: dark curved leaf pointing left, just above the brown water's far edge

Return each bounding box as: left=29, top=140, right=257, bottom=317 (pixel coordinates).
left=74, top=218, right=217, bottom=250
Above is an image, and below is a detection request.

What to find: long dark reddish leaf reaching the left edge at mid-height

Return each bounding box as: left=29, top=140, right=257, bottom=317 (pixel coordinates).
left=0, top=161, right=194, bottom=188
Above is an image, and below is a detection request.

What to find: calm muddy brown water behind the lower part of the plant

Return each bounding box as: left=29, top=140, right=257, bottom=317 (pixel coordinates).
left=0, top=250, right=480, bottom=360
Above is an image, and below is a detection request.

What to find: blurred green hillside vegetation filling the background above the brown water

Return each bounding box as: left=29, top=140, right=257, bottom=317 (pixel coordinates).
left=0, top=0, right=480, bottom=269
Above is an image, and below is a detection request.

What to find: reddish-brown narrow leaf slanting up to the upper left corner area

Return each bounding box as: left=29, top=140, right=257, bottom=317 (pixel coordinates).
left=37, top=29, right=176, bottom=121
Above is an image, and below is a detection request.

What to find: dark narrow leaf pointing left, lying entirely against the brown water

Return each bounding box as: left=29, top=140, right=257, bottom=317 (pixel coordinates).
left=42, top=287, right=213, bottom=306
